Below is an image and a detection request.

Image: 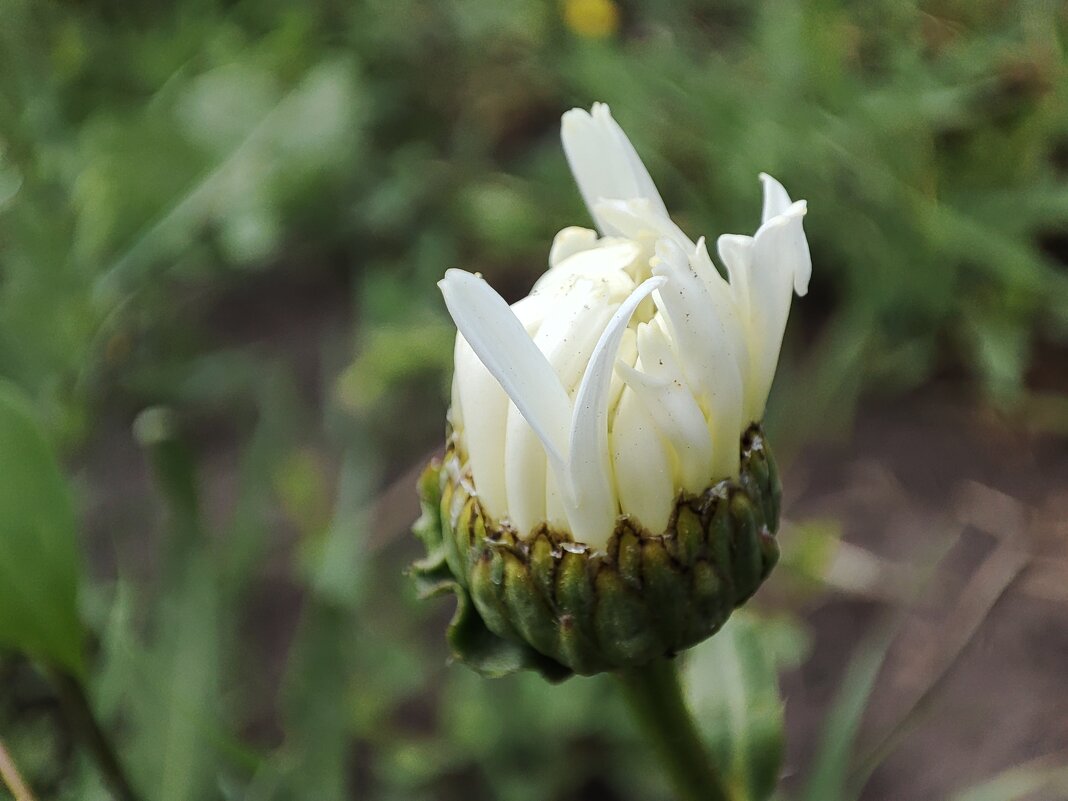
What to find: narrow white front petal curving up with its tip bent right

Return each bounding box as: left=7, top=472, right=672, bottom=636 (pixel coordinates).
left=567, top=278, right=665, bottom=543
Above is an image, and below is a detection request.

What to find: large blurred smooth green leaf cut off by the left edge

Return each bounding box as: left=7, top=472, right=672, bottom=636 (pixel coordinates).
left=0, top=381, right=85, bottom=678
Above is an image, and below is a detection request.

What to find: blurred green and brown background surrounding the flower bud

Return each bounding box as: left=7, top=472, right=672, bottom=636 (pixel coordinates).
left=0, top=0, right=1068, bottom=801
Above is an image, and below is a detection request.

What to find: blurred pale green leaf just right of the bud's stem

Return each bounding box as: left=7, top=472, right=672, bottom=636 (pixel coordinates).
left=686, top=611, right=784, bottom=801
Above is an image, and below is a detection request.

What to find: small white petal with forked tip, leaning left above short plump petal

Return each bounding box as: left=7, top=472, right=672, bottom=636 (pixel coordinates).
left=615, top=324, right=712, bottom=492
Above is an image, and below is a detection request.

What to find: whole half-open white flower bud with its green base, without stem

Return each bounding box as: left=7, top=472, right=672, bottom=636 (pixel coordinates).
left=417, top=104, right=811, bottom=676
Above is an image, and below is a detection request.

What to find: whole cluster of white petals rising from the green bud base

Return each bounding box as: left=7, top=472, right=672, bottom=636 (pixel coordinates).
left=439, top=104, right=812, bottom=548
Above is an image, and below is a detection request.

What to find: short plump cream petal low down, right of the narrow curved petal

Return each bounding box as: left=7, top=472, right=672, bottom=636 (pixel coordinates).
left=610, top=388, right=675, bottom=540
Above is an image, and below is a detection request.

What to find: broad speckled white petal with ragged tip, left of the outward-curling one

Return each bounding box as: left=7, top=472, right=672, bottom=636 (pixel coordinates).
left=653, top=239, right=748, bottom=478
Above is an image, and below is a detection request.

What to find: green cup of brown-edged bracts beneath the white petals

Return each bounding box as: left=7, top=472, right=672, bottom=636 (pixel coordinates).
left=413, top=425, right=781, bottom=680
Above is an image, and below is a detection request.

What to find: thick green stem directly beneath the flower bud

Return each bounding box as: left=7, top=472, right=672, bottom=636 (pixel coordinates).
left=617, top=659, right=733, bottom=801
